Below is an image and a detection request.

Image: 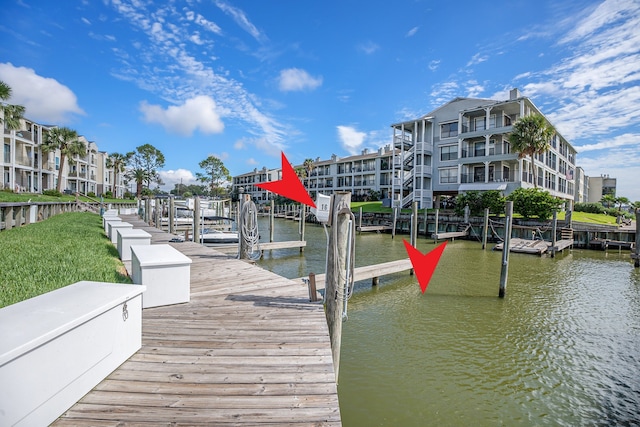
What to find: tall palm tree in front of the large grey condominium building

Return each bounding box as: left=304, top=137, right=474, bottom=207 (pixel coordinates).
left=509, top=114, right=555, bottom=188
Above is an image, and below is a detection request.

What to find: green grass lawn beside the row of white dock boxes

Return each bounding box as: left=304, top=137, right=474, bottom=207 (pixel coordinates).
left=0, top=212, right=131, bottom=307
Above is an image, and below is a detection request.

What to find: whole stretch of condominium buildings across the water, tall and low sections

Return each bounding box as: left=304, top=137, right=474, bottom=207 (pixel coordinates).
left=232, top=89, right=586, bottom=208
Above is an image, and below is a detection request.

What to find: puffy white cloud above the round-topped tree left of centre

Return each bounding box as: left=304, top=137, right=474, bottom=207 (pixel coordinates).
left=140, top=95, right=224, bottom=136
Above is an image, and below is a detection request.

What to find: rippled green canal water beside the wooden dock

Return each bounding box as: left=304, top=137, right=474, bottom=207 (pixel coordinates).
left=255, top=220, right=640, bottom=427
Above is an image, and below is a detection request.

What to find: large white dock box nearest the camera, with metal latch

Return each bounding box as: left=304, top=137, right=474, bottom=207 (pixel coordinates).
left=0, top=281, right=144, bottom=426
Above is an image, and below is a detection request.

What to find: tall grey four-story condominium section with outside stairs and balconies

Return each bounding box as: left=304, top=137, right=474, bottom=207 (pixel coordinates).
left=392, top=89, right=576, bottom=208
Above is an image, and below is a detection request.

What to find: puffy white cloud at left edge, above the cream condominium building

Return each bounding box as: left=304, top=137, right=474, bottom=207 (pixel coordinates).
left=0, top=63, right=85, bottom=124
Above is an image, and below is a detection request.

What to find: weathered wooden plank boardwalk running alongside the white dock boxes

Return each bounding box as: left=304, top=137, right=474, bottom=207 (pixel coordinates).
left=54, top=216, right=341, bottom=427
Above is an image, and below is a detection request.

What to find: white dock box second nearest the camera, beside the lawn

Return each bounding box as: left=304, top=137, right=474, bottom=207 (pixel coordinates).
left=130, top=244, right=191, bottom=308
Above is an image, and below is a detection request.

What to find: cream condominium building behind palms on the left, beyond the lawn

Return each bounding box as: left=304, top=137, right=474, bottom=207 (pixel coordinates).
left=0, top=118, right=124, bottom=197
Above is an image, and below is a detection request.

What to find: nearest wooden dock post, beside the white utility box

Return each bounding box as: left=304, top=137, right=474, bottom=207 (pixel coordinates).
left=324, top=192, right=351, bottom=382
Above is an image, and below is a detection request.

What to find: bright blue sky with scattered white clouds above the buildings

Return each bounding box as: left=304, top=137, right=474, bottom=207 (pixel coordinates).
left=0, top=0, right=640, bottom=200
